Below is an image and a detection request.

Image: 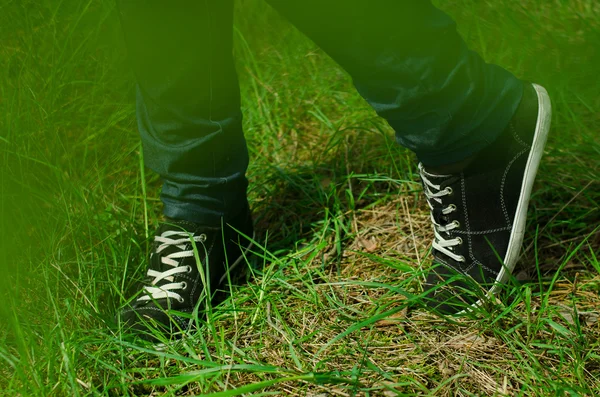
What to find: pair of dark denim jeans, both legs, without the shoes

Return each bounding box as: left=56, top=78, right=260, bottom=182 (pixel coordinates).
left=119, top=0, right=523, bottom=224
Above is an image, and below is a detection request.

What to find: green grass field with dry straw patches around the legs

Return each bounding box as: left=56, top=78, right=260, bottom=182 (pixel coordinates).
left=0, top=0, right=600, bottom=396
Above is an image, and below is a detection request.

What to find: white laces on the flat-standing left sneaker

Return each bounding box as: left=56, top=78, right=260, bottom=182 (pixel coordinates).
left=138, top=230, right=206, bottom=303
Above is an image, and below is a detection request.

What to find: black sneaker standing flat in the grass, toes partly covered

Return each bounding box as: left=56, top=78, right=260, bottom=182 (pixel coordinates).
left=120, top=206, right=253, bottom=342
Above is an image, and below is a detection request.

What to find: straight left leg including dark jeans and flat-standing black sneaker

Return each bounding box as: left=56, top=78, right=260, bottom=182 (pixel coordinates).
left=119, top=0, right=252, bottom=342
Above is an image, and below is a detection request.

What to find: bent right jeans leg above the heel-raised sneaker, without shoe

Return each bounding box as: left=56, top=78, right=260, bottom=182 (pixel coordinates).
left=267, top=0, right=523, bottom=166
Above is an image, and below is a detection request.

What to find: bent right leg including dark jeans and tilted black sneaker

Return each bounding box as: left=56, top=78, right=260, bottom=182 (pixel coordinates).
left=268, top=0, right=551, bottom=313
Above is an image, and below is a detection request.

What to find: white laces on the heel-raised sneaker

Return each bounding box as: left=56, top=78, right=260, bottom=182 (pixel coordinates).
left=419, top=164, right=465, bottom=262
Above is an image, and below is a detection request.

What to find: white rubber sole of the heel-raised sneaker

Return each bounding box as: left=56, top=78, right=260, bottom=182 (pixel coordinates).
left=464, top=84, right=552, bottom=315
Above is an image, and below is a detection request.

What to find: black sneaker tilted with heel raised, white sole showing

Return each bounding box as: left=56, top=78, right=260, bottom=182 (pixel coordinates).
left=419, top=84, right=551, bottom=314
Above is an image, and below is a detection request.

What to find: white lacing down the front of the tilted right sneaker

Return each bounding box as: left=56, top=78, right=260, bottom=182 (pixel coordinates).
left=419, top=164, right=465, bottom=262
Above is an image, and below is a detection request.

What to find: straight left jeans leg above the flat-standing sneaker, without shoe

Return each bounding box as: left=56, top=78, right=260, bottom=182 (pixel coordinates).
left=119, top=0, right=248, bottom=225
